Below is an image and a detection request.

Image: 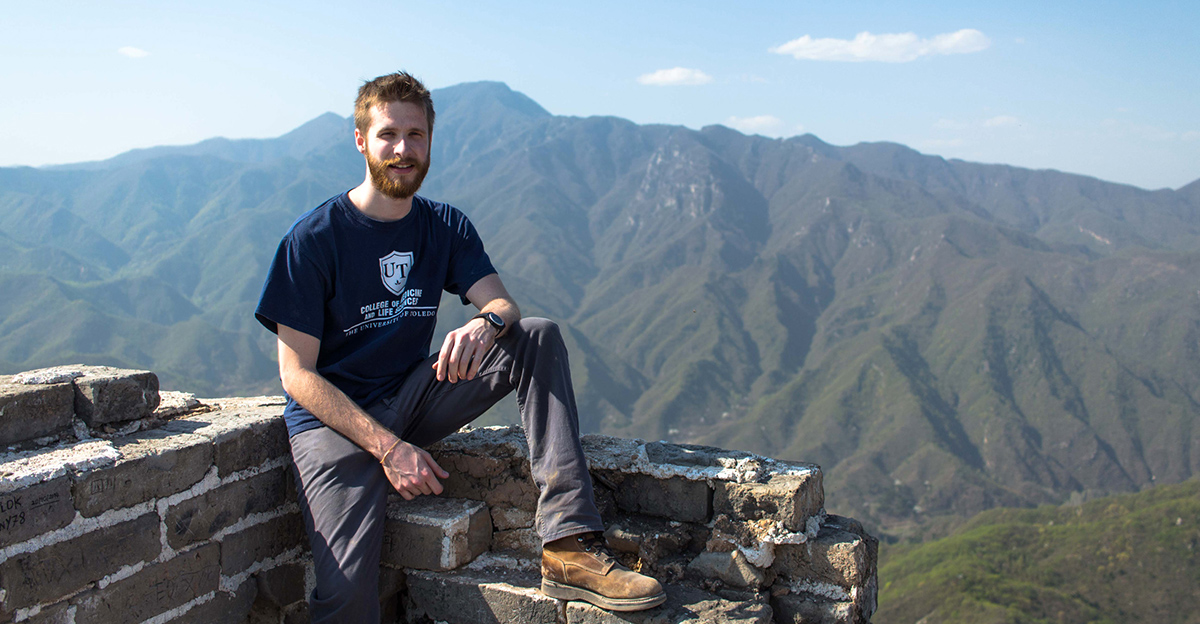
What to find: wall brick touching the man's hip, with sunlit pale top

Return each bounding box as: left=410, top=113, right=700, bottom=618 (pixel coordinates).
left=163, top=406, right=290, bottom=479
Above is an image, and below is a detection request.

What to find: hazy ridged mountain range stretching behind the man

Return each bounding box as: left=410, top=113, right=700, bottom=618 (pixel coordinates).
left=0, top=83, right=1200, bottom=534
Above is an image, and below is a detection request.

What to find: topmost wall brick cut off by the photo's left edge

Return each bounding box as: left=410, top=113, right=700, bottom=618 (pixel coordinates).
left=0, top=377, right=74, bottom=446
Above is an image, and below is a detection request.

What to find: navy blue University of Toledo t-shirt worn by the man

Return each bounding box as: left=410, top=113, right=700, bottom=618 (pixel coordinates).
left=254, top=193, right=496, bottom=436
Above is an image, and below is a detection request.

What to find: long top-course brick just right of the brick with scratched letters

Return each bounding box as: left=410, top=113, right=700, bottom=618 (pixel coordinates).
left=73, top=430, right=212, bottom=517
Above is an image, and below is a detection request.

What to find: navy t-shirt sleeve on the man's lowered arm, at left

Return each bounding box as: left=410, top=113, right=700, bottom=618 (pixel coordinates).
left=254, top=234, right=329, bottom=338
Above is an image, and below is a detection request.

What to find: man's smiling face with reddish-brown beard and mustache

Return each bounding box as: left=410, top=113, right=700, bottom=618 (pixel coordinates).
left=354, top=102, right=430, bottom=199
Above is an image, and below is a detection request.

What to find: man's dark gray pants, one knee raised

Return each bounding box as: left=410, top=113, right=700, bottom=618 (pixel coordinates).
left=292, top=318, right=604, bottom=623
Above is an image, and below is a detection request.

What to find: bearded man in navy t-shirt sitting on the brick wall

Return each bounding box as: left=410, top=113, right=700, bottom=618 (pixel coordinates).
left=256, top=72, right=666, bottom=623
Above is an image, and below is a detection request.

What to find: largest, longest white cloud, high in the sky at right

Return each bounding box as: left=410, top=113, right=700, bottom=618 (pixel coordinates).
left=769, top=28, right=991, bottom=62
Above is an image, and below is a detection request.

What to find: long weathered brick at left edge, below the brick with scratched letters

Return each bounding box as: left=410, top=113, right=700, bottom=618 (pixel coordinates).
left=0, top=514, right=162, bottom=612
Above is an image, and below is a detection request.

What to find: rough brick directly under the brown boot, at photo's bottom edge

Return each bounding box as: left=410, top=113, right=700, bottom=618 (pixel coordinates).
left=566, top=586, right=774, bottom=624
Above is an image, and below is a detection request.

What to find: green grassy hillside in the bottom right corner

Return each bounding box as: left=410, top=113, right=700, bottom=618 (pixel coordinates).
left=875, top=479, right=1200, bottom=624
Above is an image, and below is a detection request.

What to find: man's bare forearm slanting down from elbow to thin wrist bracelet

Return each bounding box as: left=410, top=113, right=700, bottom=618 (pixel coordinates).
left=284, top=368, right=397, bottom=460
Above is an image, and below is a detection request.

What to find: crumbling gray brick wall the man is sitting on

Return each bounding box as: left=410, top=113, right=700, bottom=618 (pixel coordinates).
left=0, top=367, right=876, bottom=624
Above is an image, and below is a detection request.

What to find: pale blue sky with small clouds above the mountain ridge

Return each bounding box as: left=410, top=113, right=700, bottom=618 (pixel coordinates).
left=0, top=0, right=1200, bottom=188
